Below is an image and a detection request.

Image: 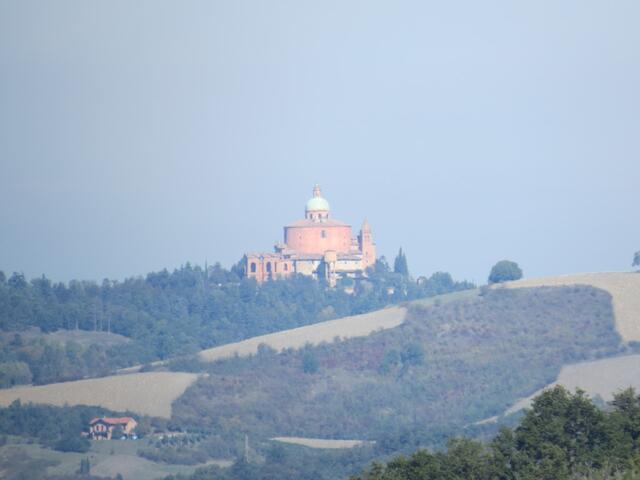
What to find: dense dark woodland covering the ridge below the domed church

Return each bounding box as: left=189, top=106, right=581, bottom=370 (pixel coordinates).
left=0, top=259, right=473, bottom=387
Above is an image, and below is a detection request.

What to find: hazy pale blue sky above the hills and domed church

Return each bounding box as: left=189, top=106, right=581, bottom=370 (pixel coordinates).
left=0, top=0, right=640, bottom=283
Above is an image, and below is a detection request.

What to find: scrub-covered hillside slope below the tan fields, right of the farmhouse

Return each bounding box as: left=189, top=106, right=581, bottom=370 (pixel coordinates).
left=174, top=287, right=620, bottom=446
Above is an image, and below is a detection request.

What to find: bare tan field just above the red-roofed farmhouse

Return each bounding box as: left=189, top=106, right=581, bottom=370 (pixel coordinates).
left=0, top=372, right=198, bottom=418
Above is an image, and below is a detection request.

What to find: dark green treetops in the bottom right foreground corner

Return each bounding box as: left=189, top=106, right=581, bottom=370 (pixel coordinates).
left=351, top=386, right=640, bottom=480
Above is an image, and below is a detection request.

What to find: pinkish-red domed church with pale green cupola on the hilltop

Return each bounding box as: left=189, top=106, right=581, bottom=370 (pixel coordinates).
left=244, top=185, right=376, bottom=286
